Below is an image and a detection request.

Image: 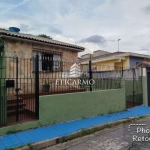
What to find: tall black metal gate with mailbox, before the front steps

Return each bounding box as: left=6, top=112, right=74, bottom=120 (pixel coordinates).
left=0, top=56, right=39, bottom=126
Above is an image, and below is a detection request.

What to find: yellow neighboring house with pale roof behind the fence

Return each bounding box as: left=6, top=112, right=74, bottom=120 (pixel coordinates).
left=80, top=50, right=150, bottom=71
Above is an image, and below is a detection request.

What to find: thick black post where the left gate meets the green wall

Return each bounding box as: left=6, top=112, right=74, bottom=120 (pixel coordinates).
left=35, top=53, right=39, bottom=119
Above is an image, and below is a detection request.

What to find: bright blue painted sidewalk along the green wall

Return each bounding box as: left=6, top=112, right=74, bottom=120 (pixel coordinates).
left=0, top=106, right=150, bottom=150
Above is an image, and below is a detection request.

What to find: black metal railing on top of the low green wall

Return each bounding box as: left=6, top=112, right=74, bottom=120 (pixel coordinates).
left=39, top=55, right=121, bottom=95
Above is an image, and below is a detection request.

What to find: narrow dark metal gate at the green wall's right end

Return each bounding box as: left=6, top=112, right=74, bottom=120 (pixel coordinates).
left=125, top=69, right=143, bottom=108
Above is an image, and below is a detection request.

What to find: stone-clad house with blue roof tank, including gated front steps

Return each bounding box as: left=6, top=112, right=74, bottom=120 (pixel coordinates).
left=0, top=27, right=84, bottom=126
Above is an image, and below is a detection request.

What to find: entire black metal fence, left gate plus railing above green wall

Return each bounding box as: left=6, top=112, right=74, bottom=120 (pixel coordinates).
left=0, top=53, right=137, bottom=126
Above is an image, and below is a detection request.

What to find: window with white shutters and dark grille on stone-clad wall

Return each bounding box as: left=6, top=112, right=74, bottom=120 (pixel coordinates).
left=32, top=52, right=61, bottom=72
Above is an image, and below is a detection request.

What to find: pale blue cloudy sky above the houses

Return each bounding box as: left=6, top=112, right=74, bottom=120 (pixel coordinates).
left=0, top=0, right=150, bottom=56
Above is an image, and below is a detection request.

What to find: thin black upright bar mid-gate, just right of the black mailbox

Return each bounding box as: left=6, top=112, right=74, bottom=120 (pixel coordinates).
left=16, top=57, right=19, bottom=122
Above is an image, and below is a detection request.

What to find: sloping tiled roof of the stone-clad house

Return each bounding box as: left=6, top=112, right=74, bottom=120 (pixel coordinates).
left=0, top=29, right=84, bottom=51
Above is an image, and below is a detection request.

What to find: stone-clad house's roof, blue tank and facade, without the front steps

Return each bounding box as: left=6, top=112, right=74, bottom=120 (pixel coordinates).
left=0, top=27, right=84, bottom=93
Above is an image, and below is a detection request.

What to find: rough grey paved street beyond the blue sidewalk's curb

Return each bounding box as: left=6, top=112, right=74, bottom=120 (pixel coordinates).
left=44, top=117, right=150, bottom=150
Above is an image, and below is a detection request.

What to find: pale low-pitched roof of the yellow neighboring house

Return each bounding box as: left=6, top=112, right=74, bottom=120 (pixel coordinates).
left=80, top=51, right=150, bottom=63
